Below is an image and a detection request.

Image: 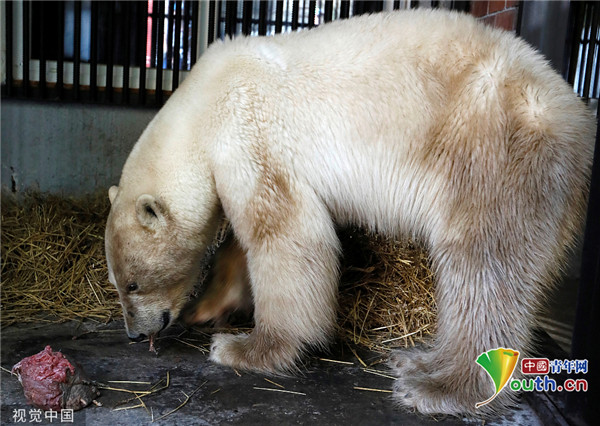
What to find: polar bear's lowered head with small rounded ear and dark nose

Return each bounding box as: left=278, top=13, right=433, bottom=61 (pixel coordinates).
left=105, top=160, right=219, bottom=340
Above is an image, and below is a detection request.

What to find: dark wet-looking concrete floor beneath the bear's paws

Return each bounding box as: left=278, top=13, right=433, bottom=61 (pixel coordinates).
left=0, top=321, right=542, bottom=426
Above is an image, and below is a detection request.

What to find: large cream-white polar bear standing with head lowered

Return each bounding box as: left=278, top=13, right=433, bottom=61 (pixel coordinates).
left=106, top=11, right=595, bottom=415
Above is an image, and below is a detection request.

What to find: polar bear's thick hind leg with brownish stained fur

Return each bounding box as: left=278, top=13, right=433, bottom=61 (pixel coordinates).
left=390, top=66, right=593, bottom=416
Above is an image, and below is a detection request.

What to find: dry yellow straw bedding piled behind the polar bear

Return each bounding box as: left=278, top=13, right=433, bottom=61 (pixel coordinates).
left=1, top=192, right=435, bottom=351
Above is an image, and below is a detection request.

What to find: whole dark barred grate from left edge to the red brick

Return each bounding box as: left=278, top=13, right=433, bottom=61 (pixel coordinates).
left=2, top=0, right=470, bottom=107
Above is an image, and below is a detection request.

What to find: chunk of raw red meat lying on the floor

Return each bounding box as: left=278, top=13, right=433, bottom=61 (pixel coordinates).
left=12, top=346, right=99, bottom=411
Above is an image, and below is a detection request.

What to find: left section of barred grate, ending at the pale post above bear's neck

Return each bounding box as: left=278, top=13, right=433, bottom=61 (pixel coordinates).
left=2, top=0, right=201, bottom=106
